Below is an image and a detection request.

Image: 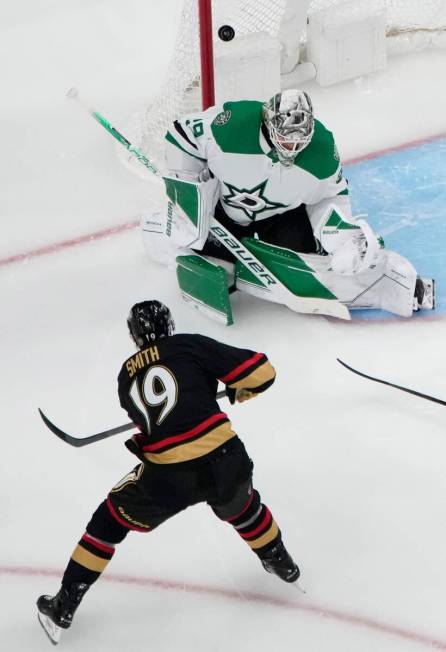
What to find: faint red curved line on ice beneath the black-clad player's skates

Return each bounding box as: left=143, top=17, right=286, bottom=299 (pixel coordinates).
left=0, top=566, right=446, bottom=651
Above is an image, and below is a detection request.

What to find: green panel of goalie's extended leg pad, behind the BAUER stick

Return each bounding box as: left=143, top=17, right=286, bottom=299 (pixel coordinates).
left=235, top=238, right=336, bottom=299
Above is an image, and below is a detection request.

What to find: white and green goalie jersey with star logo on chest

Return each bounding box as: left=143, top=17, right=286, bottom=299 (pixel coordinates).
left=166, top=101, right=351, bottom=235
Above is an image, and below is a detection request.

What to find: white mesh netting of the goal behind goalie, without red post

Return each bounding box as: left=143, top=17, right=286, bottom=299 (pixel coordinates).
left=140, top=0, right=446, bottom=165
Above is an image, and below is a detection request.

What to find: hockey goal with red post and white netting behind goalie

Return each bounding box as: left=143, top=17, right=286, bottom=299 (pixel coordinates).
left=140, top=0, right=446, bottom=165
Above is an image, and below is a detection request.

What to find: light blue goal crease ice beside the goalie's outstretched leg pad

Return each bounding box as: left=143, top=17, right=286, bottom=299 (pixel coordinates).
left=345, top=137, right=446, bottom=321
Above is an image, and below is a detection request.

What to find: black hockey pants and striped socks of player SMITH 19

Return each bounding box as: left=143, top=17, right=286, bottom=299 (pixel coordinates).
left=62, top=437, right=281, bottom=587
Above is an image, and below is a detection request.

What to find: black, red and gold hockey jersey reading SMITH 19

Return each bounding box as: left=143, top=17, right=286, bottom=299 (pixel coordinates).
left=118, top=334, right=275, bottom=464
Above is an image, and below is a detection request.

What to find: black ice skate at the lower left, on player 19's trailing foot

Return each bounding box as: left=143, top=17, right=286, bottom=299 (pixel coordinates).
left=37, top=584, right=89, bottom=645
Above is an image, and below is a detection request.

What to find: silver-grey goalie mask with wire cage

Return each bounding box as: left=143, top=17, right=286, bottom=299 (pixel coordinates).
left=263, top=89, right=314, bottom=166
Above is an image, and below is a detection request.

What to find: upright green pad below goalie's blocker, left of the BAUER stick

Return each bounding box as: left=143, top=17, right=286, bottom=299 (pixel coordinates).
left=176, top=254, right=233, bottom=326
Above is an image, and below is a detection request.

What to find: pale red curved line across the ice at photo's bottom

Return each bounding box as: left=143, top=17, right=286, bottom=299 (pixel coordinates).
left=0, top=566, right=446, bottom=650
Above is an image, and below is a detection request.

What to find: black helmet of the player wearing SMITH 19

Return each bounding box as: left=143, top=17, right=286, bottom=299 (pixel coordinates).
left=127, top=301, right=175, bottom=349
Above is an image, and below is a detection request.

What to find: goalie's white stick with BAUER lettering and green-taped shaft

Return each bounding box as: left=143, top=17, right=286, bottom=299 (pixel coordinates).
left=67, top=87, right=351, bottom=319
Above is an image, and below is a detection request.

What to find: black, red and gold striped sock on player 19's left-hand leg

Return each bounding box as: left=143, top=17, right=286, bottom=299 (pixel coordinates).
left=62, top=502, right=128, bottom=589
